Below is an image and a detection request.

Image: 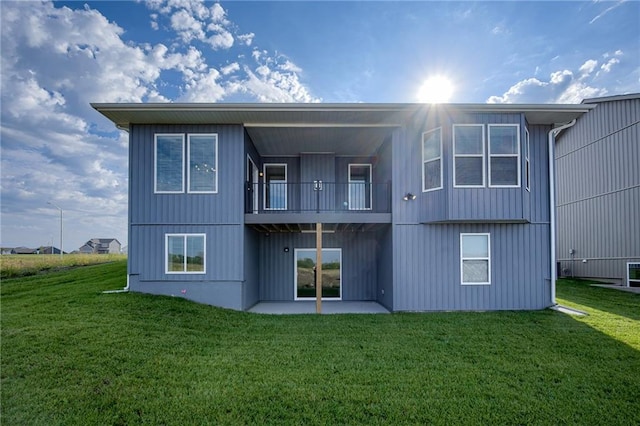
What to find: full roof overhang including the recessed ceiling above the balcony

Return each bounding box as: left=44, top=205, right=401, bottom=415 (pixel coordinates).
left=91, top=103, right=595, bottom=156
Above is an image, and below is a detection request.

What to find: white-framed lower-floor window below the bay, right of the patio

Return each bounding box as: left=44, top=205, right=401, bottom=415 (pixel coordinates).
left=460, top=234, right=491, bottom=285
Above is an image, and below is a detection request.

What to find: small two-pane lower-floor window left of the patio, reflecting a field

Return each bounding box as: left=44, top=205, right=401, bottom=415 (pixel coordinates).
left=165, top=234, right=206, bottom=274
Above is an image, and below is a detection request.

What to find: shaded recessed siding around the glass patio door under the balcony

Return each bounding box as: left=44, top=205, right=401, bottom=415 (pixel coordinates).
left=259, top=232, right=379, bottom=301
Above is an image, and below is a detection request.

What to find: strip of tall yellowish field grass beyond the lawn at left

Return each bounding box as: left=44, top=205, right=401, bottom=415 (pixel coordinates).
left=0, top=254, right=127, bottom=278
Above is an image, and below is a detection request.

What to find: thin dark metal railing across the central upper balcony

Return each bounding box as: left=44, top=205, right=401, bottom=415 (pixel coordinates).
left=245, top=181, right=391, bottom=213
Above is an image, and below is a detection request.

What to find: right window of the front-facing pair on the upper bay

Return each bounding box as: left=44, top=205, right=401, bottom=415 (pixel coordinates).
left=488, top=124, right=520, bottom=187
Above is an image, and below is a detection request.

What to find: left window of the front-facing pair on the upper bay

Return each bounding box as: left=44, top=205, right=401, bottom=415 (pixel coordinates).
left=453, top=124, right=484, bottom=187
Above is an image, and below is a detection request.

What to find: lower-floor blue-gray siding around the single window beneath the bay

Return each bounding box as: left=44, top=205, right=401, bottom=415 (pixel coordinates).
left=393, top=224, right=551, bottom=311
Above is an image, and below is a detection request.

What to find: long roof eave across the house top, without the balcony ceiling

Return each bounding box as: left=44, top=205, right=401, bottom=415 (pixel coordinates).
left=91, top=103, right=593, bottom=129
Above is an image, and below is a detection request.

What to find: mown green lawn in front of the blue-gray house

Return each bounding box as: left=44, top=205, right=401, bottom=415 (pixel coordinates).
left=1, top=262, right=640, bottom=425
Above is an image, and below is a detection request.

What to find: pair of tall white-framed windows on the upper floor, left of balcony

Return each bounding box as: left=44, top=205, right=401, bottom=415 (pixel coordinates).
left=154, top=134, right=218, bottom=194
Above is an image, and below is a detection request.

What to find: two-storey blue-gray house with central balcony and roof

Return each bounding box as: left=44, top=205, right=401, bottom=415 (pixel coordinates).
left=92, top=103, right=594, bottom=311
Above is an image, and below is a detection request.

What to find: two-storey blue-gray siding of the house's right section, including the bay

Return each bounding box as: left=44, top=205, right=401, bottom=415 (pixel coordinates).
left=392, top=114, right=551, bottom=311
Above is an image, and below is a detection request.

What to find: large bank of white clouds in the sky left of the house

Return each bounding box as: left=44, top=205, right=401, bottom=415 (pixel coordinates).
left=0, top=0, right=317, bottom=250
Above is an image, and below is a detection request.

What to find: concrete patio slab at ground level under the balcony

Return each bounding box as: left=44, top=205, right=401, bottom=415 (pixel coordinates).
left=249, top=301, right=389, bottom=315
